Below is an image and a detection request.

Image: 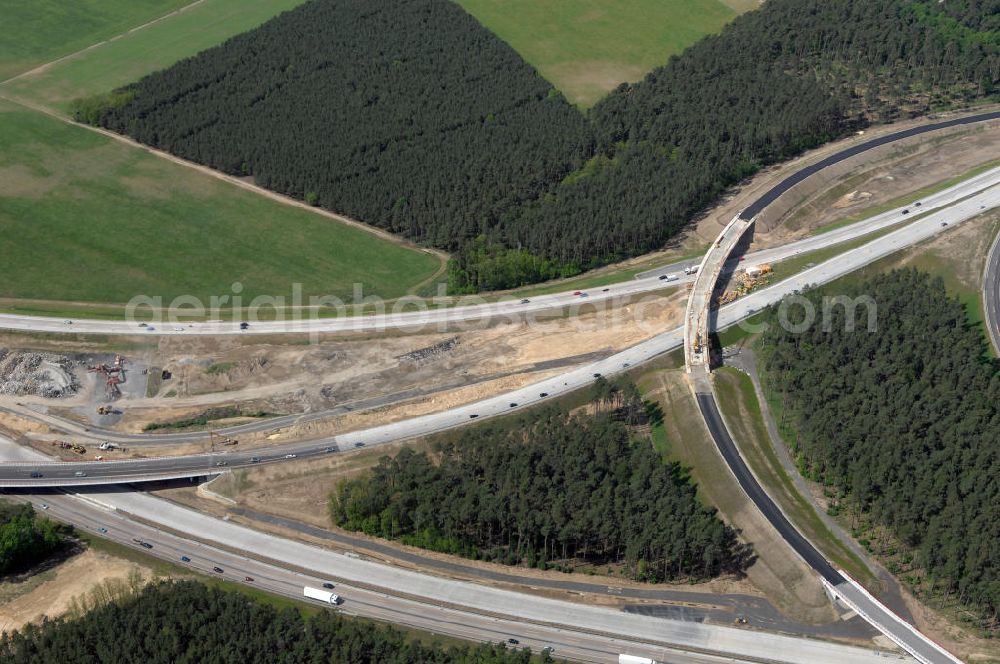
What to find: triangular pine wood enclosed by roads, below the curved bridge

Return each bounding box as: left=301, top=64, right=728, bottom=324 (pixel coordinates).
left=330, top=381, right=749, bottom=581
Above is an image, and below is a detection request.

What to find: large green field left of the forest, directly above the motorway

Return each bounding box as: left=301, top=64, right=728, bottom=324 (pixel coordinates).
left=0, top=102, right=440, bottom=303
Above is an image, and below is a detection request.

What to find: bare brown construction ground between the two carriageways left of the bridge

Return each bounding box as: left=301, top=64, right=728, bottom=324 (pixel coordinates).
left=0, top=290, right=686, bottom=443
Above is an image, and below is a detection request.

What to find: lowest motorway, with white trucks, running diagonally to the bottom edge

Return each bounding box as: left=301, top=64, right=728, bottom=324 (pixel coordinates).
left=9, top=482, right=905, bottom=664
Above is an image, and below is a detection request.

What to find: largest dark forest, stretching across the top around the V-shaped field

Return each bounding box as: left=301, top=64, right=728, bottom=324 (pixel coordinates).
left=77, top=0, right=1000, bottom=291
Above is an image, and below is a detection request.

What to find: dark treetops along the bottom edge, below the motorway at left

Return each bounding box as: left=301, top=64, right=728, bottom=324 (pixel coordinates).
left=0, top=581, right=552, bottom=664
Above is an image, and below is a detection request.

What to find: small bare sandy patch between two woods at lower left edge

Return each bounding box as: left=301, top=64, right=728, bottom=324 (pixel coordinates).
left=0, top=549, right=153, bottom=632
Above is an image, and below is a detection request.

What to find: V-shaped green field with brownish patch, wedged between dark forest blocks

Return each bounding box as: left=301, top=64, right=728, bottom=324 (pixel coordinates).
left=456, top=0, right=756, bottom=107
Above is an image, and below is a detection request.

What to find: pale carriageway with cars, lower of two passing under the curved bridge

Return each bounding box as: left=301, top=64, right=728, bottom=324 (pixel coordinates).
left=0, top=176, right=1000, bottom=487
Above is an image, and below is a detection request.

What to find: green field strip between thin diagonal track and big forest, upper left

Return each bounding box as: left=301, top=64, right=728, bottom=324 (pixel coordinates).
left=0, top=0, right=303, bottom=111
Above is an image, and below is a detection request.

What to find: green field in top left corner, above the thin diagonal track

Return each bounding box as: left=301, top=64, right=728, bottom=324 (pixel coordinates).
left=0, top=0, right=193, bottom=81
